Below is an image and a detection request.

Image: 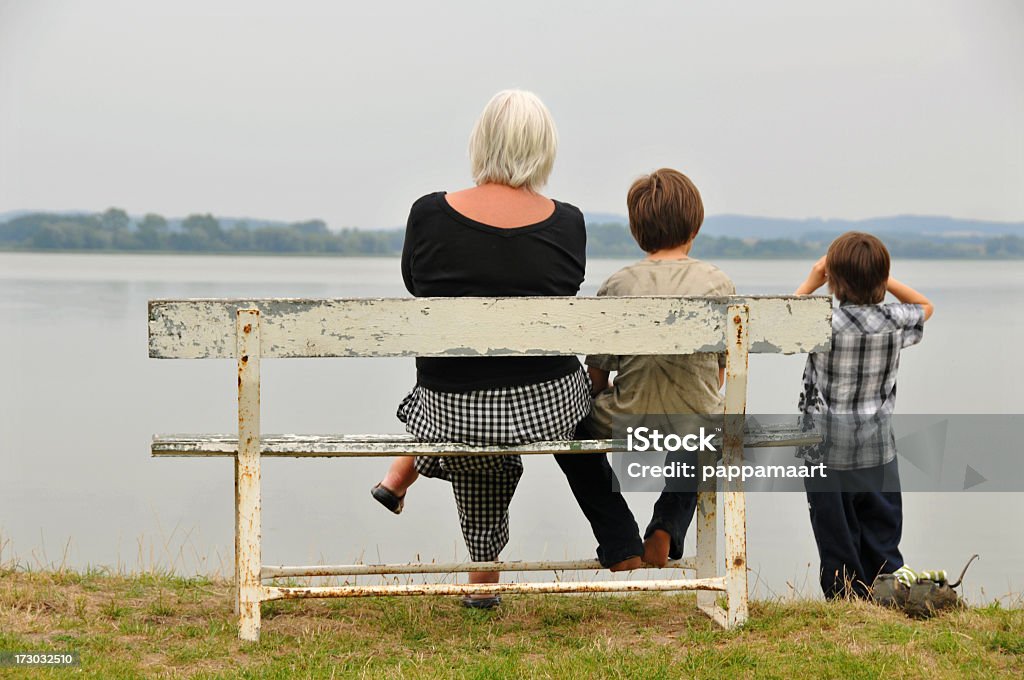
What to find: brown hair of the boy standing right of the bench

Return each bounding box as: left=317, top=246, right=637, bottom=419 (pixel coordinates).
left=825, top=231, right=889, bottom=304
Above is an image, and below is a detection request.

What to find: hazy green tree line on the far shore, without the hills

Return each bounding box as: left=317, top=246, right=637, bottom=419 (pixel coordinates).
left=0, top=208, right=1024, bottom=259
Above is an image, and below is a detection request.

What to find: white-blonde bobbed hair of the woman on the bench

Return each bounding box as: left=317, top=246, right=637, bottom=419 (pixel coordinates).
left=469, top=90, right=558, bottom=192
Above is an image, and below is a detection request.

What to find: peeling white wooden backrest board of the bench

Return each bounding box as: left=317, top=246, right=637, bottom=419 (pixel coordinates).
left=150, top=296, right=831, bottom=358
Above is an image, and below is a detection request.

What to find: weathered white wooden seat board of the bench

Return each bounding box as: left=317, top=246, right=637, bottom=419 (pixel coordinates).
left=152, top=425, right=821, bottom=458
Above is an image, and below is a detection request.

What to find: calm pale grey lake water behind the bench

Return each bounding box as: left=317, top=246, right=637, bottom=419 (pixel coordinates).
left=0, top=254, right=1024, bottom=602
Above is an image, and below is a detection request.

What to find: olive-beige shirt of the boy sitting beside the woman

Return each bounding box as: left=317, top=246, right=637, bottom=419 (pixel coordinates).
left=587, top=258, right=736, bottom=436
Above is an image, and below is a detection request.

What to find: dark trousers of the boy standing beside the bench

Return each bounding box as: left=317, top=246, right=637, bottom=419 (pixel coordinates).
left=804, top=459, right=903, bottom=599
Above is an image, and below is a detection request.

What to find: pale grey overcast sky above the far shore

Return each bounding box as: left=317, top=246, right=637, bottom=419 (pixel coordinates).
left=0, top=0, right=1024, bottom=227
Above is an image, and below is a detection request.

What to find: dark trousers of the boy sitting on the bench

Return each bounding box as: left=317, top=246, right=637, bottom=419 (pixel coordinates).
left=555, top=420, right=697, bottom=566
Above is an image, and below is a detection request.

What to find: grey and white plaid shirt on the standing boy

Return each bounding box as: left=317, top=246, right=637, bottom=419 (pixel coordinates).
left=799, top=303, right=925, bottom=469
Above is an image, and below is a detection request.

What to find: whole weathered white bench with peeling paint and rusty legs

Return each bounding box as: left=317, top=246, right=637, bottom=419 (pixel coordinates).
left=150, top=296, right=831, bottom=640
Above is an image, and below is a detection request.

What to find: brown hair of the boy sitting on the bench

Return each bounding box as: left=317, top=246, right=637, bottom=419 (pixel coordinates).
left=626, top=168, right=703, bottom=253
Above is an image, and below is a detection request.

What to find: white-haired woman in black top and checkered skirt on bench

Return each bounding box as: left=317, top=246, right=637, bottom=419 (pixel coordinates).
left=372, top=90, right=591, bottom=608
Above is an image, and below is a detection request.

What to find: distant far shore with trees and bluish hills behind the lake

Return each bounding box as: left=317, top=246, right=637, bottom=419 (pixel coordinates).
left=0, top=208, right=1024, bottom=259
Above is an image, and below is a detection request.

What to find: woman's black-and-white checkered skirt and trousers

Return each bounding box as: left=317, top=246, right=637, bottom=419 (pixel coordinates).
left=397, top=367, right=591, bottom=562
